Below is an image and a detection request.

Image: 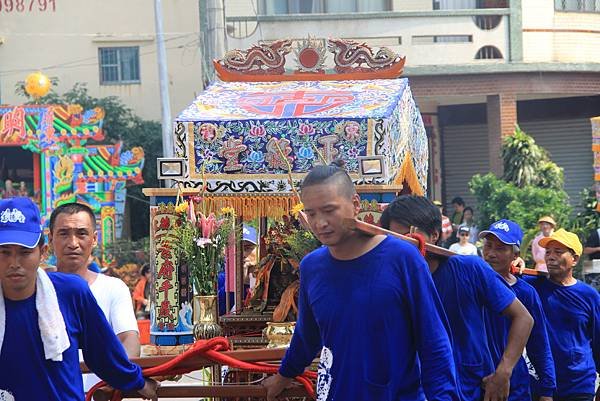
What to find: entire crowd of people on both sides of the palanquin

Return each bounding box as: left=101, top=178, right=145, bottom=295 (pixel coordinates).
left=0, top=160, right=600, bottom=401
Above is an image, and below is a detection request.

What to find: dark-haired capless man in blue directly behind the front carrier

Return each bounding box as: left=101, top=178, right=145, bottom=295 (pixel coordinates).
left=380, top=195, right=533, bottom=401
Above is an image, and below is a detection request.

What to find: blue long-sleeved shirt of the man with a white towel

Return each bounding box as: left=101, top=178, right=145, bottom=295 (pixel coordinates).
left=0, top=273, right=144, bottom=401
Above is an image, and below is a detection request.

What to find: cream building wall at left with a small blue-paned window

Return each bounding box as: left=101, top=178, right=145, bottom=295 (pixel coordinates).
left=0, top=0, right=203, bottom=120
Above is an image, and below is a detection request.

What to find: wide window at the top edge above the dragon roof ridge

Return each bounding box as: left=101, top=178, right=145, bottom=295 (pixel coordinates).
left=258, top=0, right=391, bottom=15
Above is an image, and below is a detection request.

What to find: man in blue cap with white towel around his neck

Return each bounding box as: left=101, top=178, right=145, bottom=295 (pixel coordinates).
left=0, top=198, right=157, bottom=401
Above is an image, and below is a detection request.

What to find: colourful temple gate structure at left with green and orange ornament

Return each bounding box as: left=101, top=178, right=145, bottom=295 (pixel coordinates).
left=0, top=104, right=144, bottom=265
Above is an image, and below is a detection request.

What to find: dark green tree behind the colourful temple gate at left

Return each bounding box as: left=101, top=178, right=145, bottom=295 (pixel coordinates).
left=16, top=79, right=162, bottom=240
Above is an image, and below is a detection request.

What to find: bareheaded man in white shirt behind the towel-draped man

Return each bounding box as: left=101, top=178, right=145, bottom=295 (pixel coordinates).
left=48, top=203, right=140, bottom=391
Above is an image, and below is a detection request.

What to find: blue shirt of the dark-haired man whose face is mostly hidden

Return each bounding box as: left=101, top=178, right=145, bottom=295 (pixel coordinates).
left=432, top=256, right=515, bottom=401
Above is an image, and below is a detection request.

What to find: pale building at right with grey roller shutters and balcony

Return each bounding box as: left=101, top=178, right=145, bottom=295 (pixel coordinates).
left=225, top=0, right=600, bottom=211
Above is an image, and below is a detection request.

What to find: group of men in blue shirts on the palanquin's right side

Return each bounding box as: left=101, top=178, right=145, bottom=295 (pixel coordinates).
left=264, top=165, right=600, bottom=401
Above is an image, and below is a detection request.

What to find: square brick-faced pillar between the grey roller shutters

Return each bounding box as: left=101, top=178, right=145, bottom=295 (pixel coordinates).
left=487, top=93, right=517, bottom=176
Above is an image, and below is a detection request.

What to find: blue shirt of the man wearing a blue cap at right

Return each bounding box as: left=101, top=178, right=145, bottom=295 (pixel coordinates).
left=486, top=279, right=556, bottom=401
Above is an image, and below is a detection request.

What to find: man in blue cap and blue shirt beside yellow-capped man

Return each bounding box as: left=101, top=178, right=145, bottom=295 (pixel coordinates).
left=479, top=220, right=556, bottom=401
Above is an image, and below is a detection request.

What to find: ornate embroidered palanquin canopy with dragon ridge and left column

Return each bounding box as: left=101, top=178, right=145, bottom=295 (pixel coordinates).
left=144, top=38, right=428, bottom=345
